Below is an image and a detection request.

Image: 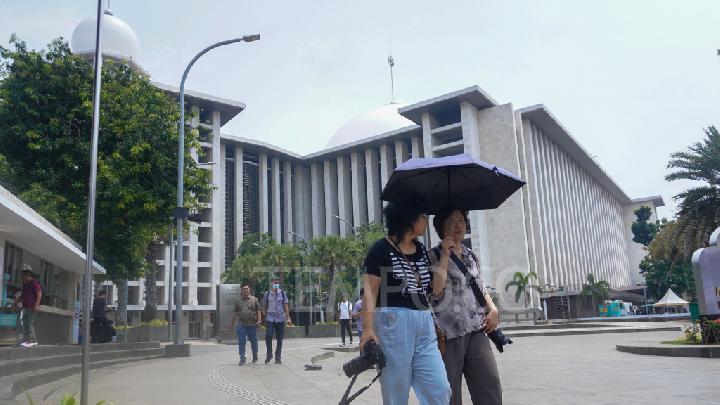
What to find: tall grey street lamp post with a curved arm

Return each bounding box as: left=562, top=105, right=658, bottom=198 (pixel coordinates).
left=173, top=34, right=260, bottom=345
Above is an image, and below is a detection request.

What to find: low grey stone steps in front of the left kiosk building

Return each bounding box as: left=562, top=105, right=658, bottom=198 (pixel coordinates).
left=0, top=342, right=165, bottom=404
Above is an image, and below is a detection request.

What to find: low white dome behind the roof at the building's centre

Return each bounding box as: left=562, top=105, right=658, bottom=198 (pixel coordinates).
left=325, top=104, right=415, bottom=149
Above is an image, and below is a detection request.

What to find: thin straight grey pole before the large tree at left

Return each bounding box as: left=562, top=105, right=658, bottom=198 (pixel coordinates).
left=80, top=0, right=103, bottom=405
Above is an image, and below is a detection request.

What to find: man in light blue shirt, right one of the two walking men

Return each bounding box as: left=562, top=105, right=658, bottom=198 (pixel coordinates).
left=262, top=277, right=292, bottom=364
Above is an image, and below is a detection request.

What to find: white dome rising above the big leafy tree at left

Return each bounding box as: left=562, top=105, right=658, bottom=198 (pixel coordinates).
left=70, top=11, right=140, bottom=66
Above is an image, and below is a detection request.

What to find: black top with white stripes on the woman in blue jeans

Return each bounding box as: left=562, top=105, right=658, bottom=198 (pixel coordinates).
left=365, top=238, right=432, bottom=310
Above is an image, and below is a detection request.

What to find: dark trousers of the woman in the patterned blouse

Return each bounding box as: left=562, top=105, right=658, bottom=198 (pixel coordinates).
left=443, top=332, right=502, bottom=405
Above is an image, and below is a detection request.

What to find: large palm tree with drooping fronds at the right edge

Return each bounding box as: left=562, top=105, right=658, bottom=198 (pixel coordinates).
left=651, top=126, right=720, bottom=261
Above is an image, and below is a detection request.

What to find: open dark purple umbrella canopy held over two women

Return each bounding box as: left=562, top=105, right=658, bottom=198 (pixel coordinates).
left=380, top=153, right=525, bottom=214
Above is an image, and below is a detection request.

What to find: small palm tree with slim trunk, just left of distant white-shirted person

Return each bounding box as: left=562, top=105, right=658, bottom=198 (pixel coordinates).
left=308, top=235, right=350, bottom=319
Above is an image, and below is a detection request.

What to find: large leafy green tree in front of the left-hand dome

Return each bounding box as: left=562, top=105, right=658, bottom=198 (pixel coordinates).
left=0, top=36, right=212, bottom=324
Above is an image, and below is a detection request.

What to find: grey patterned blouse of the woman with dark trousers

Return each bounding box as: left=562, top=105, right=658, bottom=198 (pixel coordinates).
left=428, top=244, right=486, bottom=340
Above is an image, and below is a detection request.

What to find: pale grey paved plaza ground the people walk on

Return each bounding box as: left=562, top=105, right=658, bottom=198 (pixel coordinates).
left=16, top=326, right=720, bottom=405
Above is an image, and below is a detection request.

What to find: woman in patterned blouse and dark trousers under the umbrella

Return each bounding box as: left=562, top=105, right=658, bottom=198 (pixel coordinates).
left=429, top=206, right=502, bottom=405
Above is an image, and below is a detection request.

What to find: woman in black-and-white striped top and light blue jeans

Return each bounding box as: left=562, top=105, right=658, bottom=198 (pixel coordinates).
left=360, top=197, right=450, bottom=405
